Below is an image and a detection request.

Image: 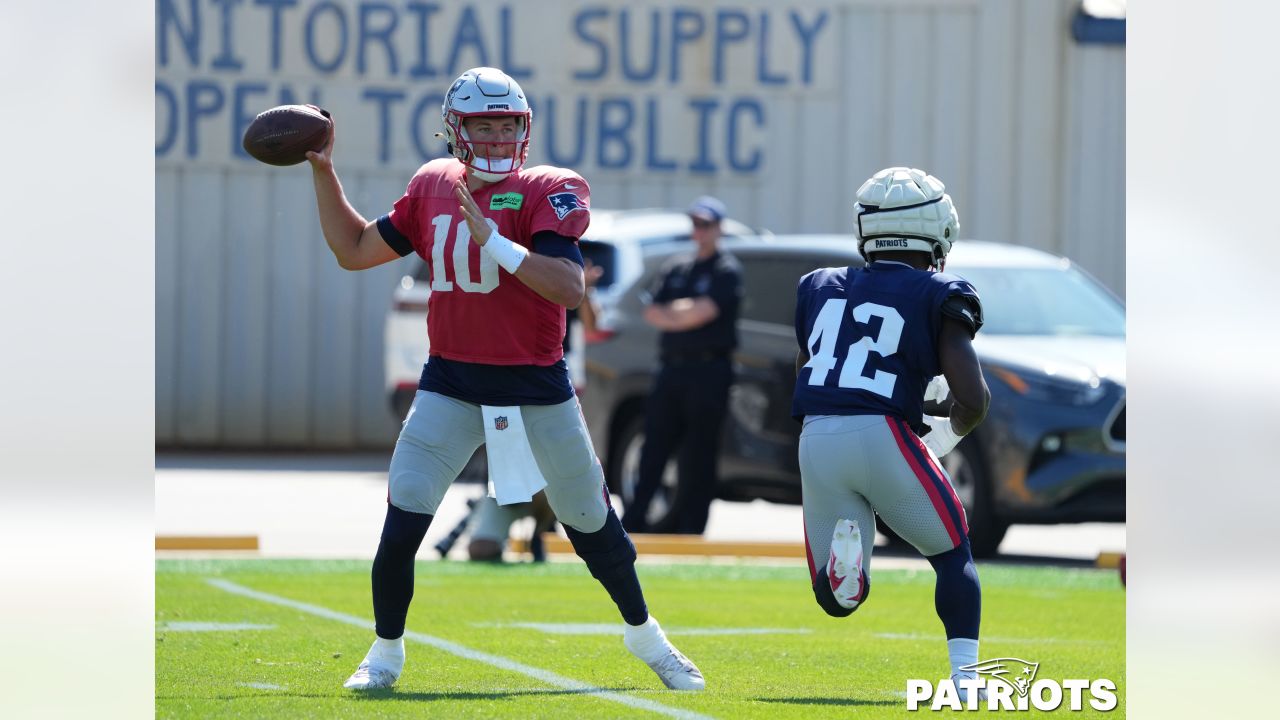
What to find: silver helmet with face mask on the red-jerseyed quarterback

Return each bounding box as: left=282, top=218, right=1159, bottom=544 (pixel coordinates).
left=440, top=68, right=534, bottom=182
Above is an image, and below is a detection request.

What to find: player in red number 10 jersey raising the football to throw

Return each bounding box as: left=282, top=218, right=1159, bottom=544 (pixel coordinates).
left=307, top=68, right=704, bottom=691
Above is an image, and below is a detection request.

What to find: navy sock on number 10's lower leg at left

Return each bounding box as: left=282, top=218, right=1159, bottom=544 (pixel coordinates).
left=371, top=503, right=433, bottom=641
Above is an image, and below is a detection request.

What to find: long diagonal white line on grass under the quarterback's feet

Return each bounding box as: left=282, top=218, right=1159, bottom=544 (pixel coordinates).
left=205, top=578, right=712, bottom=720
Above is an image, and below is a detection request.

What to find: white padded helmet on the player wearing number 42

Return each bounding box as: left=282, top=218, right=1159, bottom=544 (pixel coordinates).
left=854, top=168, right=960, bottom=270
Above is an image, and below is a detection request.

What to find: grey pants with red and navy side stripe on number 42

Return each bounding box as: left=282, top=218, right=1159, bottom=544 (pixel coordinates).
left=800, top=415, right=969, bottom=577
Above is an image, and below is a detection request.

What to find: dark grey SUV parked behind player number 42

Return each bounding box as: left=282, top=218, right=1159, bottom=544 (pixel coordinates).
left=581, top=236, right=1125, bottom=556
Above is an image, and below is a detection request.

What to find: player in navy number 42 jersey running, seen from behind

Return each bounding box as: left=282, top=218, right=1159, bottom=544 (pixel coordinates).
left=792, top=168, right=991, bottom=698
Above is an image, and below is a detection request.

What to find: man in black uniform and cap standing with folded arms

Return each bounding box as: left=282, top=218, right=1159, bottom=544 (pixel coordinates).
left=622, top=197, right=742, bottom=534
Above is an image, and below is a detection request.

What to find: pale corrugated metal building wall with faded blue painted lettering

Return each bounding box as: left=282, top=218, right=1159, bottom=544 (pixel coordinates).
left=156, top=0, right=1124, bottom=448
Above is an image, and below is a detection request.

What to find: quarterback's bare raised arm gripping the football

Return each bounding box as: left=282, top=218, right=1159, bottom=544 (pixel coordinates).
left=307, top=124, right=401, bottom=270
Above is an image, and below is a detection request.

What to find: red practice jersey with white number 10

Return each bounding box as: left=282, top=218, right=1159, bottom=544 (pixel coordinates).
left=388, top=158, right=591, bottom=365
